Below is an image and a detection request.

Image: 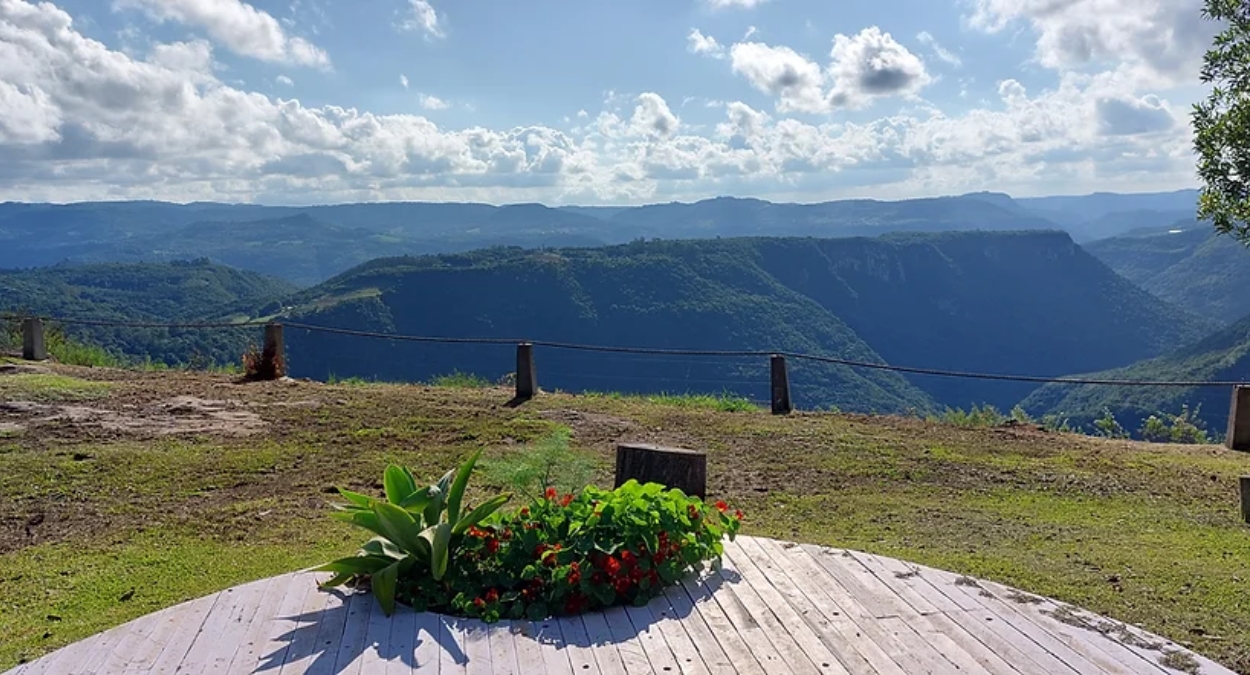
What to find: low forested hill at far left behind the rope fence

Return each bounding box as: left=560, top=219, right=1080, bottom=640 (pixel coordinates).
left=0, top=260, right=296, bottom=364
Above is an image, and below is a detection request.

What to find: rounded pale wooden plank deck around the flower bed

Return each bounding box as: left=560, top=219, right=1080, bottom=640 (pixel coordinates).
left=9, top=536, right=1233, bottom=675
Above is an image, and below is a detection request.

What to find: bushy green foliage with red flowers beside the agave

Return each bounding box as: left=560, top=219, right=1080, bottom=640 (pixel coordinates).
left=400, top=480, right=741, bottom=621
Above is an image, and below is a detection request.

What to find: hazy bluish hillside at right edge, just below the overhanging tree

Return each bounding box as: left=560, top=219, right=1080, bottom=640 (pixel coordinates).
left=1085, top=220, right=1250, bottom=325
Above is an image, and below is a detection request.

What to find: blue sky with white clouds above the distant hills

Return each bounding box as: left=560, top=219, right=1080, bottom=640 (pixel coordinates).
left=0, top=0, right=1216, bottom=204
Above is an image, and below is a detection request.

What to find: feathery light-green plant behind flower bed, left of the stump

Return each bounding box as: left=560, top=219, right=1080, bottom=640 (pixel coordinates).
left=481, top=426, right=596, bottom=499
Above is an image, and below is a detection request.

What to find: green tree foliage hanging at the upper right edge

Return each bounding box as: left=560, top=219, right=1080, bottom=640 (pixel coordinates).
left=1191, top=0, right=1250, bottom=244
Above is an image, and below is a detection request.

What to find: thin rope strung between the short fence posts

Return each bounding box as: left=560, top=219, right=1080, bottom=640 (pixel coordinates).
left=0, top=314, right=1250, bottom=389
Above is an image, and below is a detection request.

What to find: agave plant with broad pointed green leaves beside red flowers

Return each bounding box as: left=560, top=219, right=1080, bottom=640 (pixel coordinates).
left=315, top=449, right=513, bottom=616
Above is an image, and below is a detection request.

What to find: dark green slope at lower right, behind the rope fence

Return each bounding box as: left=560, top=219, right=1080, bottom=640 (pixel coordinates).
left=1023, top=316, right=1250, bottom=433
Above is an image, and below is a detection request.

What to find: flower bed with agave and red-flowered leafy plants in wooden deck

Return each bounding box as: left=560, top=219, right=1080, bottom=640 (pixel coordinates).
left=319, top=454, right=743, bottom=621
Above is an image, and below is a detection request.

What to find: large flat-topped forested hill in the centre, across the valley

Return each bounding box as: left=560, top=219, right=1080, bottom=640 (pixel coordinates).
left=289, top=231, right=1213, bottom=411
